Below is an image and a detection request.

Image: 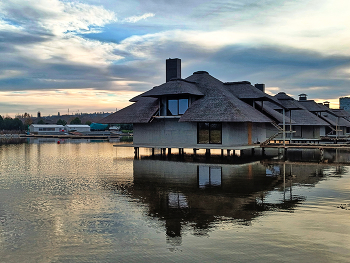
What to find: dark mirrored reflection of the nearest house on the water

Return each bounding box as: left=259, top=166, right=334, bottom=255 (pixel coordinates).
left=102, top=159, right=340, bottom=248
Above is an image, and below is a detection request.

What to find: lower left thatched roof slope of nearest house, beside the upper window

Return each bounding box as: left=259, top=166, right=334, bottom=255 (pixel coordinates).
left=100, top=98, right=159, bottom=124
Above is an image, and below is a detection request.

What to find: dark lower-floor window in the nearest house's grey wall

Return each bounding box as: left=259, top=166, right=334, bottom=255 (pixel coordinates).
left=197, top=122, right=222, bottom=144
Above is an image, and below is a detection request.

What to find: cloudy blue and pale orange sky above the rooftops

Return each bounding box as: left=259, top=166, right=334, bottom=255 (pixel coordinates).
left=0, top=0, right=350, bottom=117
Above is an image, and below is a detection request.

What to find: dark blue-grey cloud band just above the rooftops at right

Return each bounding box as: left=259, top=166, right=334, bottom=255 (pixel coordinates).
left=189, top=46, right=350, bottom=88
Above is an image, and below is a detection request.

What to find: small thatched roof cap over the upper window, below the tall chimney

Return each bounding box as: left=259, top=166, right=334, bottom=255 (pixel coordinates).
left=141, top=79, right=204, bottom=98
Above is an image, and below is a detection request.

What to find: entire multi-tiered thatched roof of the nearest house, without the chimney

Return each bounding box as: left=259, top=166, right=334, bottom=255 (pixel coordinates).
left=108, top=71, right=292, bottom=123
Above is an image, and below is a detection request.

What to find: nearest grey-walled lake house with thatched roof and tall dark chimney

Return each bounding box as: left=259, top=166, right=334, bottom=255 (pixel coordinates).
left=101, top=58, right=283, bottom=157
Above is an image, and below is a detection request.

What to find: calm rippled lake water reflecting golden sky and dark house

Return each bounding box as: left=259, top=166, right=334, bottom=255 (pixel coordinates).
left=0, top=141, right=350, bottom=263
